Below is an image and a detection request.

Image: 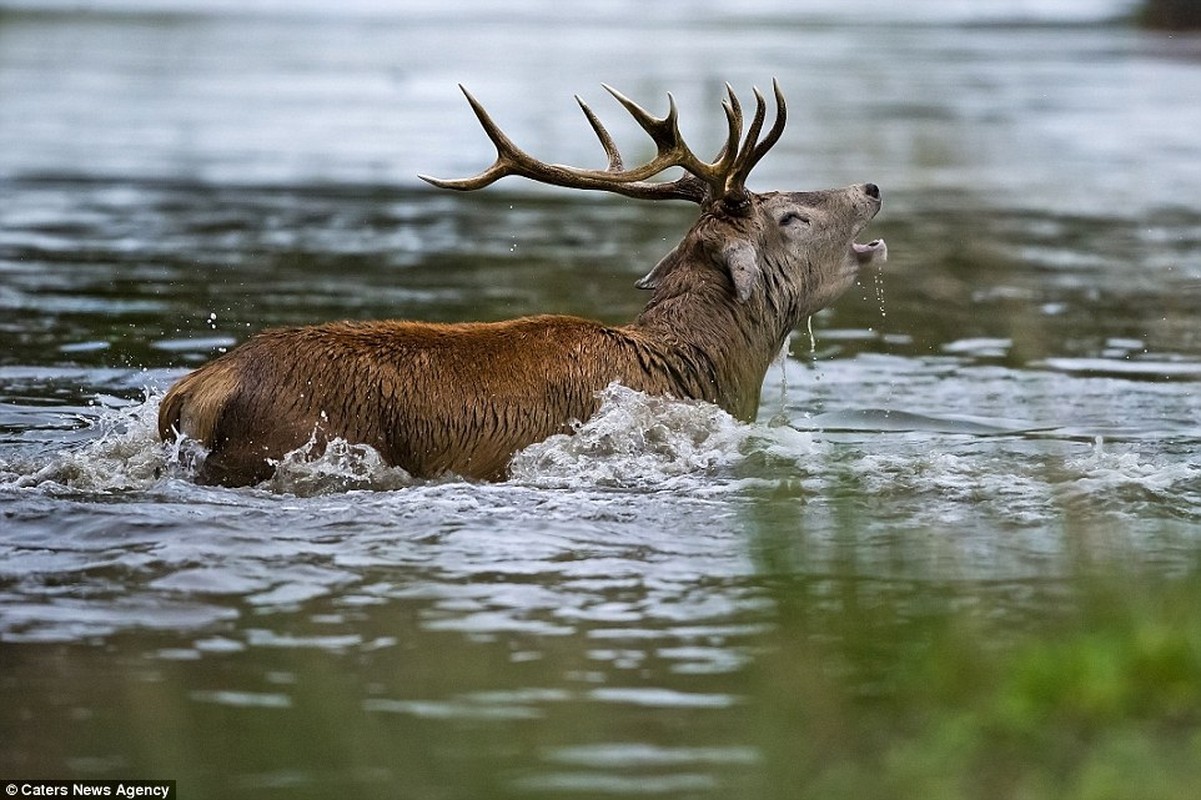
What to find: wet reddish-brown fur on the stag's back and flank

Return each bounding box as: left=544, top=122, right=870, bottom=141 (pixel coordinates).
left=160, top=316, right=715, bottom=484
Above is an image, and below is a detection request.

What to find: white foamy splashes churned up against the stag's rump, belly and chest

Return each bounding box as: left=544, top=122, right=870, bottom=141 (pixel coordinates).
left=0, top=384, right=814, bottom=496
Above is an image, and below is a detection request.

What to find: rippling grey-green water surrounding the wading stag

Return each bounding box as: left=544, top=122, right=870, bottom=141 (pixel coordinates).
left=0, top=0, right=1201, bottom=798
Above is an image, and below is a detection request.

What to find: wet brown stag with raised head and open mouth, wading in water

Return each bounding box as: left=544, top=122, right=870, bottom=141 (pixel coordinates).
left=159, top=79, right=888, bottom=486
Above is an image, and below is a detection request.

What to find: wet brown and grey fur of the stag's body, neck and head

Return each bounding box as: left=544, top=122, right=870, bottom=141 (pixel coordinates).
left=159, top=187, right=879, bottom=485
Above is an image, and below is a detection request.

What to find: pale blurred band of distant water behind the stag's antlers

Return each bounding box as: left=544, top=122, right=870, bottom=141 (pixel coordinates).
left=0, top=0, right=1201, bottom=209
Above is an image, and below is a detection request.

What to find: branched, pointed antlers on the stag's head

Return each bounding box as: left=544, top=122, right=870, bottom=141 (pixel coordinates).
left=418, top=79, right=787, bottom=204
